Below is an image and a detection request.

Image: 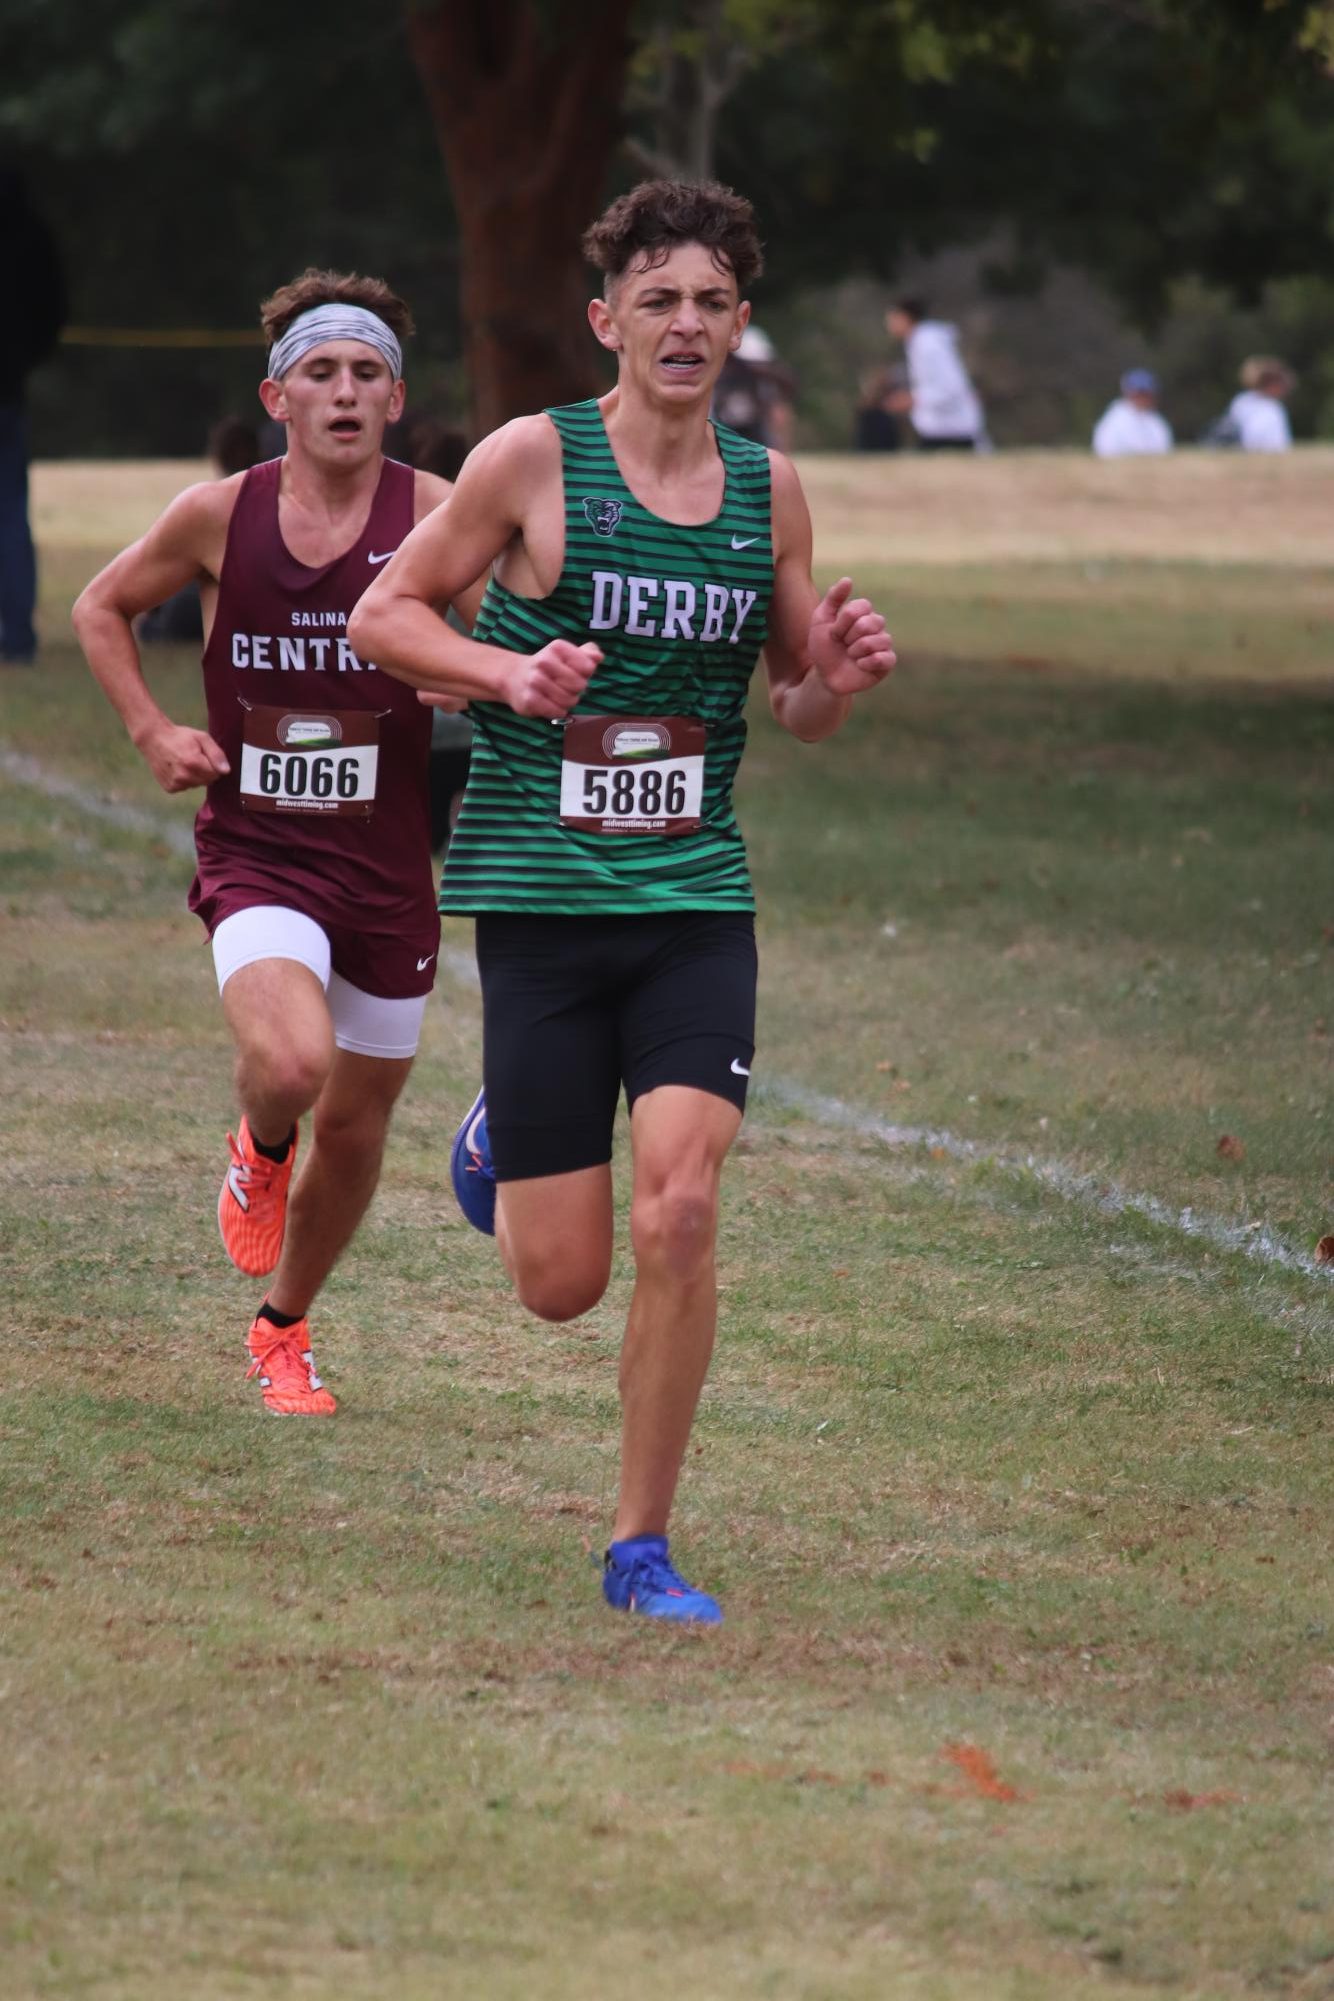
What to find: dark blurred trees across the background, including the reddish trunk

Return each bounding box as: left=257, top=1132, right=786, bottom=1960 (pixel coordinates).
left=0, top=0, right=1334, bottom=452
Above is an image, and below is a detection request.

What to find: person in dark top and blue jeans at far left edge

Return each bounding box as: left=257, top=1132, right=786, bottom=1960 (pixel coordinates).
left=0, top=164, right=66, bottom=666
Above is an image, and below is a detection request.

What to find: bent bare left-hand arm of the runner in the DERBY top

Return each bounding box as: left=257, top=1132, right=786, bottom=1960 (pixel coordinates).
left=348, top=416, right=602, bottom=716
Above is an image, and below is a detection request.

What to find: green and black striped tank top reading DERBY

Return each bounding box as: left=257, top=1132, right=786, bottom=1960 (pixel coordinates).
left=440, top=402, right=774, bottom=916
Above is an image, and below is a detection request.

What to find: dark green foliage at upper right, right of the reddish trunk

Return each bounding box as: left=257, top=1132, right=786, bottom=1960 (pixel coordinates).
left=684, top=0, right=1334, bottom=318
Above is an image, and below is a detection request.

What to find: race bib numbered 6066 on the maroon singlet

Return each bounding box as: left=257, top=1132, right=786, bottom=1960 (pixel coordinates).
left=240, top=708, right=380, bottom=818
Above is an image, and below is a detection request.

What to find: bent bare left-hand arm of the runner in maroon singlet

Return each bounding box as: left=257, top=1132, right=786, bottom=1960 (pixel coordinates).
left=72, top=480, right=240, bottom=792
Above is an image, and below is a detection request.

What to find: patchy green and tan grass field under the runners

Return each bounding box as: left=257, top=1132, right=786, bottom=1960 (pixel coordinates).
left=0, top=452, right=1334, bottom=2001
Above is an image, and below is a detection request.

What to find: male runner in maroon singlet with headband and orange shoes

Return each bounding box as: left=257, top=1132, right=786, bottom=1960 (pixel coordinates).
left=74, top=270, right=480, bottom=1415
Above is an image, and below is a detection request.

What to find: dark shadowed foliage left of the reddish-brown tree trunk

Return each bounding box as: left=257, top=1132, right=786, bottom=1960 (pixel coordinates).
left=0, top=0, right=460, bottom=452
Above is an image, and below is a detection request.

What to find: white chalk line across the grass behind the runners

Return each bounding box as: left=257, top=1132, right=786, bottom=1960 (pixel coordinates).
left=0, top=744, right=1334, bottom=1283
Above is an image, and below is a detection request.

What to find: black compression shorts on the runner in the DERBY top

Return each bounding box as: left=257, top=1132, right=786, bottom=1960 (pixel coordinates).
left=478, top=910, right=756, bottom=1181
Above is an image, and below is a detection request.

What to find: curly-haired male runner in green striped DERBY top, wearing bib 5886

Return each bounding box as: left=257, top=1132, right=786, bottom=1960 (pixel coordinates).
left=350, top=182, right=894, bottom=1623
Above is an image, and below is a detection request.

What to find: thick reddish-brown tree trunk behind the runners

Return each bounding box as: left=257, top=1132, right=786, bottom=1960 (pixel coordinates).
left=408, top=0, right=632, bottom=436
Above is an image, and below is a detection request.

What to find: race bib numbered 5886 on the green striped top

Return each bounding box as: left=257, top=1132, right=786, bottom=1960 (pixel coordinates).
left=560, top=716, right=706, bottom=834
